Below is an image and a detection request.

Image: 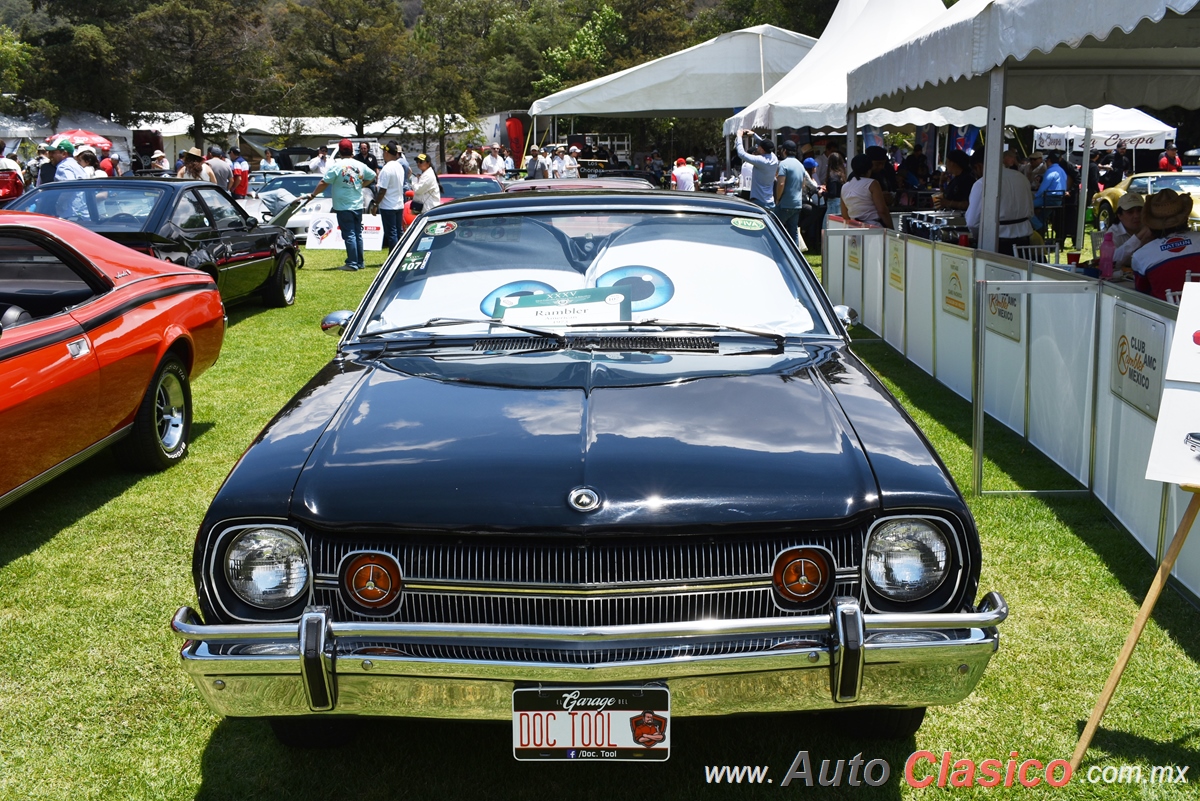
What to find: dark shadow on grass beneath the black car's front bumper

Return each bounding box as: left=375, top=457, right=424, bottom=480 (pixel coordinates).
left=196, top=713, right=916, bottom=801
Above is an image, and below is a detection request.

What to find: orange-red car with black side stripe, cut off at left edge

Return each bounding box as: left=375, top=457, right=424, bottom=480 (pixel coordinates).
left=0, top=212, right=226, bottom=507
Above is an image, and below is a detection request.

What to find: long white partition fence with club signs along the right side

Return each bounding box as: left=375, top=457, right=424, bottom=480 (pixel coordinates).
left=826, top=231, right=1200, bottom=595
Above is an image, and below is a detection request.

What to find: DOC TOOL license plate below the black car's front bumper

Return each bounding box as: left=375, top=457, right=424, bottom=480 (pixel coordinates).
left=512, top=687, right=671, bottom=761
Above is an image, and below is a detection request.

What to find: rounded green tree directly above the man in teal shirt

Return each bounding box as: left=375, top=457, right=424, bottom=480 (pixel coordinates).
left=277, top=0, right=409, bottom=137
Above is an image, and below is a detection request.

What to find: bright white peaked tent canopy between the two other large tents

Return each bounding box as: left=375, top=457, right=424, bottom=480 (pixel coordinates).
left=725, top=0, right=948, bottom=134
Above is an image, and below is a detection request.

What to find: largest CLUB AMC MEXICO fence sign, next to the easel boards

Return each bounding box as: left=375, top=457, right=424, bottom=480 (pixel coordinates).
left=1110, top=303, right=1166, bottom=420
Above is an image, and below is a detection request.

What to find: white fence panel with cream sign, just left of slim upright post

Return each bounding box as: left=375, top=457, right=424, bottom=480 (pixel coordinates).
left=934, top=243, right=974, bottom=401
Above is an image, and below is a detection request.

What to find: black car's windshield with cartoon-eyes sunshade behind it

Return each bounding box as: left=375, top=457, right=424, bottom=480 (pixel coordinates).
left=360, top=211, right=828, bottom=337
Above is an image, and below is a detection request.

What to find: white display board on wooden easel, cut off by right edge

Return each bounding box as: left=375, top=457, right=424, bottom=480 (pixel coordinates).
left=1146, top=282, right=1200, bottom=484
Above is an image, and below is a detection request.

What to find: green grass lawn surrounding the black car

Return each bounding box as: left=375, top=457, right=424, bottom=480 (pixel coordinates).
left=0, top=252, right=1200, bottom=801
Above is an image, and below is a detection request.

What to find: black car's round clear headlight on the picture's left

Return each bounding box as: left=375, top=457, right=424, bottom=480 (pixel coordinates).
left=226, top=528, right=308, bottom=609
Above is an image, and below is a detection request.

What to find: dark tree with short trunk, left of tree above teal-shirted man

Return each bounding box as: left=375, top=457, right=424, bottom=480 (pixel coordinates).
left=128, top=0, right=270, bottom=147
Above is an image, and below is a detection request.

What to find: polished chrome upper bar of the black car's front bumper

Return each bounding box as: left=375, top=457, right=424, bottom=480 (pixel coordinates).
left=170, top=592, right=1008, bottom=646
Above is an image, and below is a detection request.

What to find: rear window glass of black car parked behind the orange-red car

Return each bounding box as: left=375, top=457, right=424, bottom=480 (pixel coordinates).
left=7, top=181, right=167, bottom=233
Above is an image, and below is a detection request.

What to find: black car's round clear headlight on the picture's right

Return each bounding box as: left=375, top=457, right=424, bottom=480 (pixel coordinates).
left=866, top=518, right=950, bottom=601
